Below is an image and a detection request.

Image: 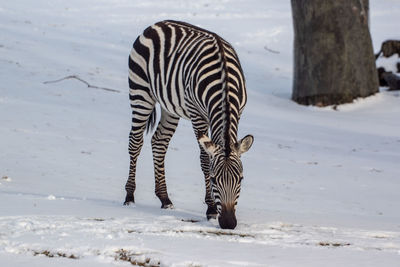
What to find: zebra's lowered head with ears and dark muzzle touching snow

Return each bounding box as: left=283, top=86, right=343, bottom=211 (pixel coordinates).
left=199, top=135, right=254, bottom=229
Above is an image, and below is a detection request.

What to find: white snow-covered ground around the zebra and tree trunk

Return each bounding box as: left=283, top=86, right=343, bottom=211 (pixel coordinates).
left=0, top=0, right=400, bottom=266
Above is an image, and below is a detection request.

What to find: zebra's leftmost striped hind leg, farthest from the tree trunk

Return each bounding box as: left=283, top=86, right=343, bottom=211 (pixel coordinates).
left=124, top=101, right=155, bottom=205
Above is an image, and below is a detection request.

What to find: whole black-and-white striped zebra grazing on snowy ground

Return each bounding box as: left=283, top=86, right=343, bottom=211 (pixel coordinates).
left=124, top=20, right=254, bottom=229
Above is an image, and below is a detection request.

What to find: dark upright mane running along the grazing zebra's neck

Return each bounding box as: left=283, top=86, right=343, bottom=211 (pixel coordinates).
left=213, top=33, right=231, bottom=157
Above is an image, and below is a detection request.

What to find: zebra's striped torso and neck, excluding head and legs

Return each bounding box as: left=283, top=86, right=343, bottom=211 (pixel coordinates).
left=130, top=20, right=246, bottom=155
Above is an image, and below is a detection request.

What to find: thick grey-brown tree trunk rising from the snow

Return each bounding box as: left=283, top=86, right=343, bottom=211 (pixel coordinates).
left=291, top=0, right=379, bottom=106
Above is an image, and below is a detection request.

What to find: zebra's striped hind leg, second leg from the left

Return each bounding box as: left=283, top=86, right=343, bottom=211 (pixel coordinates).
left=151, top=110, right=179, bottom=209
